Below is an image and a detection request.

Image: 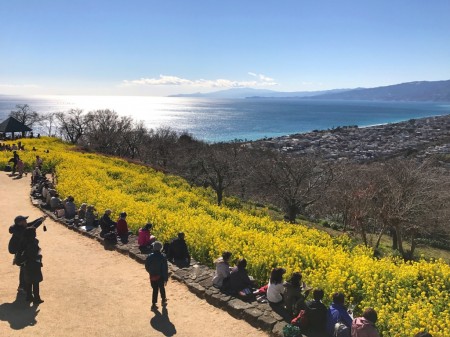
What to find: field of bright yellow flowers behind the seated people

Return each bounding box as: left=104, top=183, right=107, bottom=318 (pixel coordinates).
left=0, top=138, right=450, bottom=337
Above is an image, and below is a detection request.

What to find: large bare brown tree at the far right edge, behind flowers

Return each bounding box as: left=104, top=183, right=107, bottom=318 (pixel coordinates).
left=375, top=159, right=449, bottom=259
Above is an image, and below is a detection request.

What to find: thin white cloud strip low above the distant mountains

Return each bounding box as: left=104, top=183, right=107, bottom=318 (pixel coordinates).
left=121, top=73, right=277, bottom=88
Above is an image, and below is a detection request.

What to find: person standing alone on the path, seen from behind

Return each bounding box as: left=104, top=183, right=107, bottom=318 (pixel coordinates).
left=145, top=241, right=169, bottom=310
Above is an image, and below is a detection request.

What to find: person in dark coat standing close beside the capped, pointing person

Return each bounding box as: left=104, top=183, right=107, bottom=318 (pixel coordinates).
left=22, top=227, right=44, bottom=305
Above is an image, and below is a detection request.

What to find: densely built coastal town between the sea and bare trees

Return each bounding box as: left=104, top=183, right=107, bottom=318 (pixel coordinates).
left=246, top=115, right=450, bottom=162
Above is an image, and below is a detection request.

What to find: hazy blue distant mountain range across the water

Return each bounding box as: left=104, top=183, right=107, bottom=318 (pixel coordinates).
left=170, top=80, right=450, bottom=102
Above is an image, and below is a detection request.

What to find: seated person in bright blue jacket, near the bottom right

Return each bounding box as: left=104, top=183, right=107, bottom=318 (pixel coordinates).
left=327, top=293, right=353, bottom=337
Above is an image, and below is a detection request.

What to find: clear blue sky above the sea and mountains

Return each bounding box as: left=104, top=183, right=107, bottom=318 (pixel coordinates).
left=0, top=0, right=450, bottom=96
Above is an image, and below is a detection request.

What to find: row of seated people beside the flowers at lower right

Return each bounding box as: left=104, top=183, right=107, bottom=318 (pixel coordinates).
left=212, top=251, right=431, bottom=337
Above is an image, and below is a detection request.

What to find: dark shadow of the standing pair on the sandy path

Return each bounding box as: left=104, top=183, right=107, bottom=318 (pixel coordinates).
left=0, top=293, right=39, bottom=330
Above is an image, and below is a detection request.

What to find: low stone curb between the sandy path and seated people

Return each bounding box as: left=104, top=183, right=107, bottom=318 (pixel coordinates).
left=31, top=196, right=287, bottom=337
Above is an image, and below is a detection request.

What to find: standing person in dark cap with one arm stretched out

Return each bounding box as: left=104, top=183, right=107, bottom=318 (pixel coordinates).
left=8, top=215, right=46, bottom=291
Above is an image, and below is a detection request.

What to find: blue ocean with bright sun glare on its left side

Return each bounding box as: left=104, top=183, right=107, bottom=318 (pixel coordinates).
left=0, top=95, right=450, bottom=142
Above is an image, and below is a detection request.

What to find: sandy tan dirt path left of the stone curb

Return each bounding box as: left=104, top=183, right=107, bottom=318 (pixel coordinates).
left=0, top=172, right=267, bottom=337
